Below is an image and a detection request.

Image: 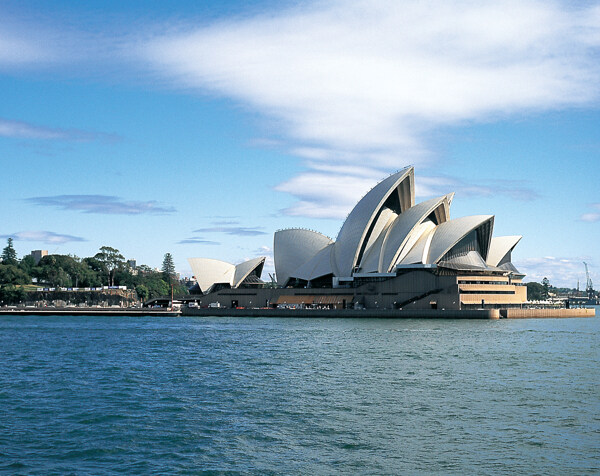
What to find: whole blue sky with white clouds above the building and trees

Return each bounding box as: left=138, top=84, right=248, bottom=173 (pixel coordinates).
left=0, top=0, right=600, bottom=286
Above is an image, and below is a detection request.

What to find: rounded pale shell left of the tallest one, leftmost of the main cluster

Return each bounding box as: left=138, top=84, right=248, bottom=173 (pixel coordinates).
left=273, top=228, right=333, bottom=286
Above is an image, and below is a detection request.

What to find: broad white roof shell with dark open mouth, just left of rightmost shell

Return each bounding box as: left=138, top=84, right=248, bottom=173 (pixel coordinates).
left=426, top=215, right=494, bottom=264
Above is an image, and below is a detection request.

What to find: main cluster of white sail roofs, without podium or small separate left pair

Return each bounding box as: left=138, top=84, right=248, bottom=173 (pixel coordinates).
left=274, top=167, right=522, bottom=286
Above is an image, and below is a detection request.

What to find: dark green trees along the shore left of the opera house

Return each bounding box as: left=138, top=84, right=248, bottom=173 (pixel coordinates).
left=0, top=238, right=187, bottom=303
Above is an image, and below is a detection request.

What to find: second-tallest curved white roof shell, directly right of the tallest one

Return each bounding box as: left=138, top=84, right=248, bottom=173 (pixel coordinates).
left=377, top=194, right=454, bottom=273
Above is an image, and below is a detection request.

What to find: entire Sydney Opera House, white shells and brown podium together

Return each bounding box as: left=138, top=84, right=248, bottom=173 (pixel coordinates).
left=188, top=167, right=526, bottom=309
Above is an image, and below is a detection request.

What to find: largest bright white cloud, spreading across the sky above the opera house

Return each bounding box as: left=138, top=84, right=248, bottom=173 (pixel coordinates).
left=143, top=0, right=600, bottom=217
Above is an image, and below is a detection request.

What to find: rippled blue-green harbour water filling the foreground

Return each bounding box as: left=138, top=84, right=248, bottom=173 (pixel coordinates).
left=0, top=316, right=600, bottom=475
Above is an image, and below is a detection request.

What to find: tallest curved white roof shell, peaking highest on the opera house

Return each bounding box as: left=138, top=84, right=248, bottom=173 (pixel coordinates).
left=332, top=167, right=415, bottom=276
